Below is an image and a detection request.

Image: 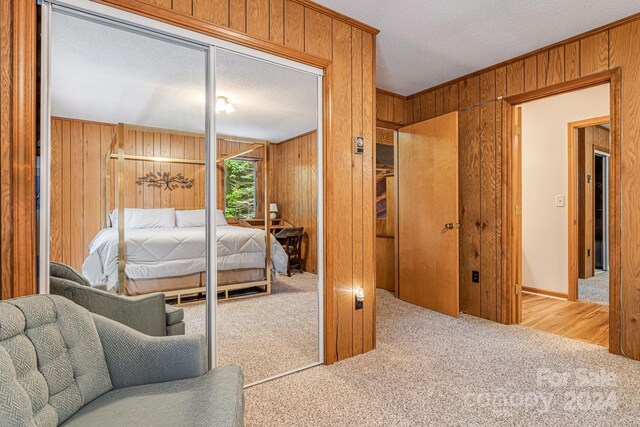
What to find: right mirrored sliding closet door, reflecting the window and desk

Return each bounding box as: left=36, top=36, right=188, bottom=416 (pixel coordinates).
left=215, top=49, right=319, bottom=384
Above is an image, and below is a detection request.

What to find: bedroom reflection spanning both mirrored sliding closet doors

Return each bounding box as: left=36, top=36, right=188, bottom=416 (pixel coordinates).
left=49, top=5, right=321, bottom=385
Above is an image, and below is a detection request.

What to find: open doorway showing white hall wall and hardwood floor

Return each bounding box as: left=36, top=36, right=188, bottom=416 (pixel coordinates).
left=507, top=80, right=616, bottom=348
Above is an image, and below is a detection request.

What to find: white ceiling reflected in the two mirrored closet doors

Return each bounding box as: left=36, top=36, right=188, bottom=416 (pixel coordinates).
left=51, top=13, right=317, bottom=142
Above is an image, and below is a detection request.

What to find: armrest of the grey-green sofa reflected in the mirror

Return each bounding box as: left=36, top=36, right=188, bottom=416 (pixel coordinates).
left=50, top=277, right=167, bottom=336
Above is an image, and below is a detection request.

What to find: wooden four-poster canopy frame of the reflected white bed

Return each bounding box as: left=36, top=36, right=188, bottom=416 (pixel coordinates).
left=104, top=123, right=272, bottom=304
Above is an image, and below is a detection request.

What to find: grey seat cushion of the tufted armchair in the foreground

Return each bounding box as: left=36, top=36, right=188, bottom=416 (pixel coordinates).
left=63, top=366, right=244, bottom=427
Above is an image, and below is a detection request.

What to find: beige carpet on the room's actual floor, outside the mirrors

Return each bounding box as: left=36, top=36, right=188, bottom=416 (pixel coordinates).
left=245, top=291, right=640, bottom=427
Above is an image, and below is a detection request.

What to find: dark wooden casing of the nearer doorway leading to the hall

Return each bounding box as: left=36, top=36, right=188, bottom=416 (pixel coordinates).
left=502, top=68, right=622, bottom=354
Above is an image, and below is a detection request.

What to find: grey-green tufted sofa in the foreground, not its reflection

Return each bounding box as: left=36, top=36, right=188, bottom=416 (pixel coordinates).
left=0, top=295, right=244, bottom=427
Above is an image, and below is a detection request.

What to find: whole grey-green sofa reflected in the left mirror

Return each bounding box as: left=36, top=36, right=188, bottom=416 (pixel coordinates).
left=49, top=262, right=184, bottom=336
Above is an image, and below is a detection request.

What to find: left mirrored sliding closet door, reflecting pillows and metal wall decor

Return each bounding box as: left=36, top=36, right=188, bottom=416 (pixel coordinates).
left=49, top=7, right=207, bottom=335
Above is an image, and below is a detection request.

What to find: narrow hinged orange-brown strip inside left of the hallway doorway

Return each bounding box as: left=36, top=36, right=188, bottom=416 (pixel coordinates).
left=511, top=107, right=522, bottom=323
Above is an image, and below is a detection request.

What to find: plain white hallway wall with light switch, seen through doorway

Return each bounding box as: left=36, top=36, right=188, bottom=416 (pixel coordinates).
left=522, top=84, right=609, bottom=294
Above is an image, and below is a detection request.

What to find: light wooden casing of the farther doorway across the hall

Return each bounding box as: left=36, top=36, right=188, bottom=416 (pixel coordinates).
left=567, top=116, right=611, bottom=301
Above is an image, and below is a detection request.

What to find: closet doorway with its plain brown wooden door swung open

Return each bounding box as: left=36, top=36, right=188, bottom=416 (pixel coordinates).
left=376, top=112, right=460, bottom=317
